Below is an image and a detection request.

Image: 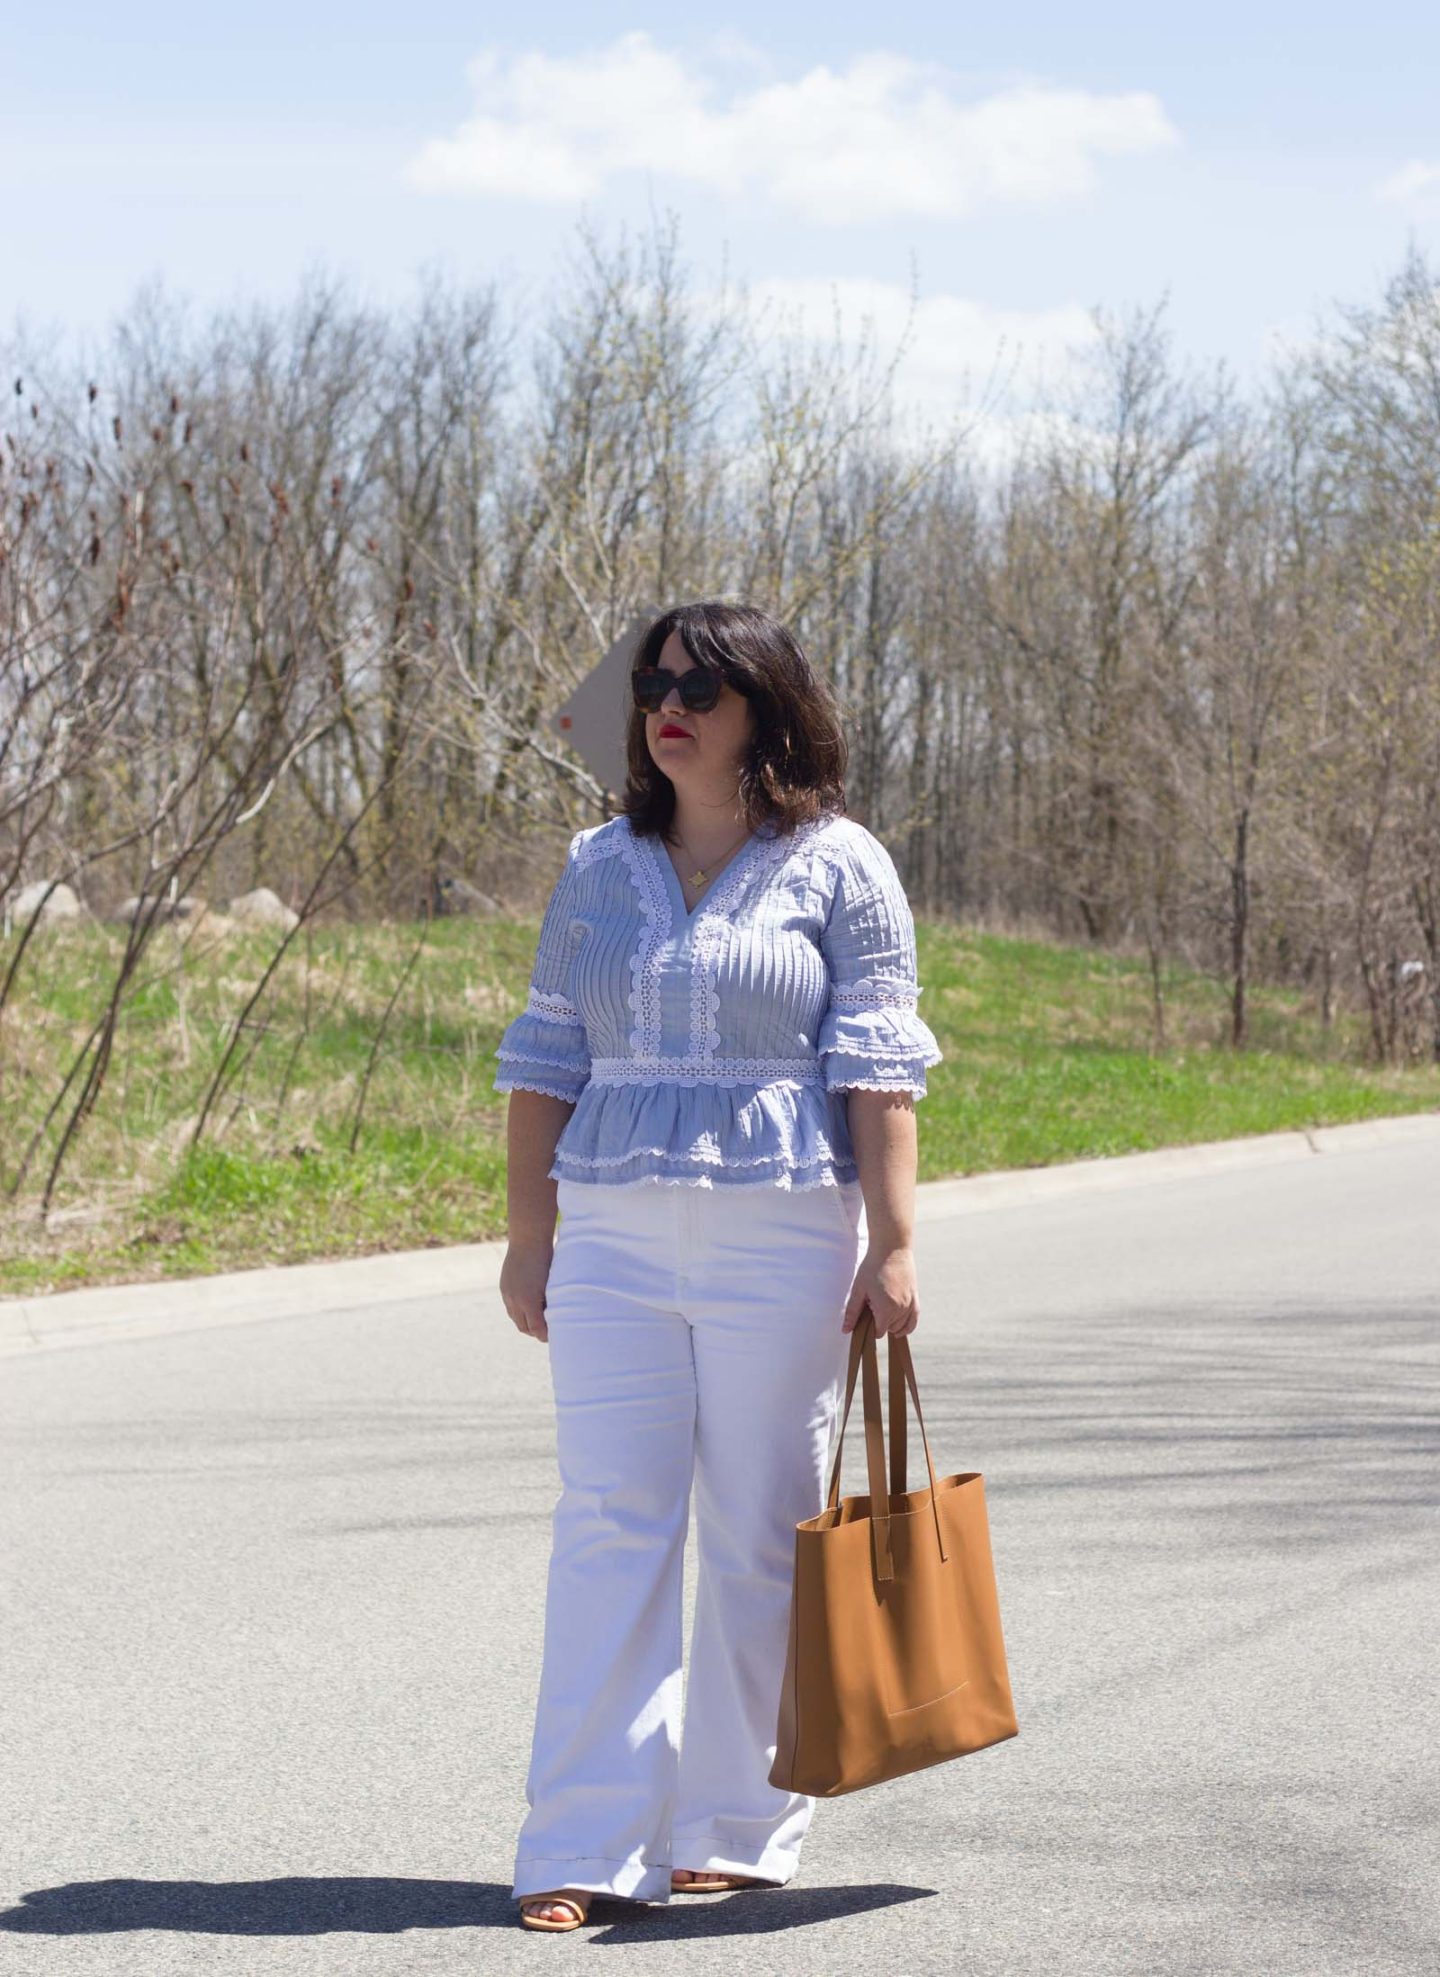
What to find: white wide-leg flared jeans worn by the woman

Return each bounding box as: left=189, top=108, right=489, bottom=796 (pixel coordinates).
left=514, top=1180, right=868, bottom=1902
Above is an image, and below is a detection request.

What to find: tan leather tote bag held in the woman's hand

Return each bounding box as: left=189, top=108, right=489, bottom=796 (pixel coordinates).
left=769, top=1305, right=1019, bottom=1799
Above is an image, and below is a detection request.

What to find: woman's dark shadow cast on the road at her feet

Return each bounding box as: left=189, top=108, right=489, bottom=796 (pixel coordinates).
left=0, top=1874, right=936, bottom=1941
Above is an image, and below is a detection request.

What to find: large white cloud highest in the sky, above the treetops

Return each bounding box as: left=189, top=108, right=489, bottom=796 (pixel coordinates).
left=405, top=32, right=1179, bottom=223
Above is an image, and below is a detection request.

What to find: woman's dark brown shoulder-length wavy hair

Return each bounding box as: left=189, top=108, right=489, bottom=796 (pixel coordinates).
left=619, top=601, right=849, bottom=836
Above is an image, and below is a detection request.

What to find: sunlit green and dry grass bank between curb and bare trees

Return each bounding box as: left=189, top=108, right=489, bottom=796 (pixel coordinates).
left=0, top=921, right=1440, bottom=1295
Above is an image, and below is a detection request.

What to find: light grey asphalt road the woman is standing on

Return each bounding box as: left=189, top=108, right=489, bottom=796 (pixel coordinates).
left=0, top=1133, right=1440, bottom=1977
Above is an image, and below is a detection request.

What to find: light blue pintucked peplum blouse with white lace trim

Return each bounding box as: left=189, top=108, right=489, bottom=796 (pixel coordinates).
left=495, top=815, right=942, bottom=1188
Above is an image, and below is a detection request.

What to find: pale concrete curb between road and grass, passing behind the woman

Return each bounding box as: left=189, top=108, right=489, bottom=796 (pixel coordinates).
left=0, top=1111, right=1440, bottom=1358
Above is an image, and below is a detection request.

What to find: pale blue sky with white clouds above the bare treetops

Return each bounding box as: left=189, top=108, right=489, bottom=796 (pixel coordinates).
left=0, top=0, right=1440, bottom=425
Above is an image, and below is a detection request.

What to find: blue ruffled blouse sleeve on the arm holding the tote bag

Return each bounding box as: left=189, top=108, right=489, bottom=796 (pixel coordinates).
left=815, top=832, right=944, bottom=1099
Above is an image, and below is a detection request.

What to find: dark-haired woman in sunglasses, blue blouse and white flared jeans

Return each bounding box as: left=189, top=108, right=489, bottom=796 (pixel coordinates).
left=495, top=603, right=940, bottom=1930
